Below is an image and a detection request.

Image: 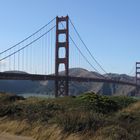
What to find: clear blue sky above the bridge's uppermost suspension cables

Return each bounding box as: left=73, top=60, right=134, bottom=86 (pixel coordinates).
left=0, top=0, right=140, bottom=73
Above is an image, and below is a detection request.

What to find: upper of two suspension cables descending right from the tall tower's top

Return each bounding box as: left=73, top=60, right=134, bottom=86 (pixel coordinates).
left=69, top=18, right=107, bottom=74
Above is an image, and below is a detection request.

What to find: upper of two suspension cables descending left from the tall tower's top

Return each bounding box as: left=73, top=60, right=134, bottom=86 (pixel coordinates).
left=0, top=18, right=55, bottom=55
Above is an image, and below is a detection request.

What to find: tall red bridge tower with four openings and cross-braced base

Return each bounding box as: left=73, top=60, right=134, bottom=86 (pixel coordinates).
left=55, top=16, right=69, bottom=97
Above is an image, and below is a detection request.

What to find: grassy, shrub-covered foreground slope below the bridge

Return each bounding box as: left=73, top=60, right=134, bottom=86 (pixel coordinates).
left=0, top=93, right=140, bottom=140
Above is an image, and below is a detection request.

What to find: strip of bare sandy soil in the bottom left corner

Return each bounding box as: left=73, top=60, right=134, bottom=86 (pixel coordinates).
left=0, top=133, right=34, bottom=140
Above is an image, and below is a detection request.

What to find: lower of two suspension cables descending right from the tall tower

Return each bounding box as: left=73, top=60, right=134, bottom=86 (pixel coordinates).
left=61, top=23, right=107, bottom=79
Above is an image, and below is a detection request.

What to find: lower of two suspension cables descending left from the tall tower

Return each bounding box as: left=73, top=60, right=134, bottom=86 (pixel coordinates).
left=0, top=25, right=56, bottom=61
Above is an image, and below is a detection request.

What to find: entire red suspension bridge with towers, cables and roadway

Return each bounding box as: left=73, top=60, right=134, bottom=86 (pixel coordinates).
left=0, top=16, right=140, bottom=97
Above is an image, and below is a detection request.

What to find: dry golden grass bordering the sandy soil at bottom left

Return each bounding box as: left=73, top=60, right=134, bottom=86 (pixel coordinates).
left=0, top=118, right=86, bottom=140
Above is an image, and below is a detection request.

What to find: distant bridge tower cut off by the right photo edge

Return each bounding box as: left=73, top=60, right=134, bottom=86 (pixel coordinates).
left=136, top=62, right=140, bottom=95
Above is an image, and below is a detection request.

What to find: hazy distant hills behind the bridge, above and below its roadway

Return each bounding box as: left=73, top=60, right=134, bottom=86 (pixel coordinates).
left=0, top=68, right=135, bottom=95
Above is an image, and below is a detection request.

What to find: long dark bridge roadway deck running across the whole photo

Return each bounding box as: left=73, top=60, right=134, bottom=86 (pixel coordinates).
left=0, top=72, right=140, bottom=87
